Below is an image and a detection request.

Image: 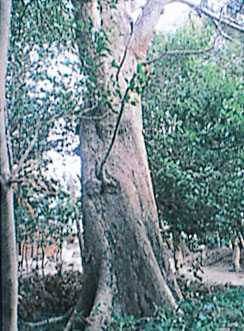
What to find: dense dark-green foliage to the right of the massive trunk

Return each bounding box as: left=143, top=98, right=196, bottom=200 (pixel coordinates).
left=143, top=27, right=244, bottom=246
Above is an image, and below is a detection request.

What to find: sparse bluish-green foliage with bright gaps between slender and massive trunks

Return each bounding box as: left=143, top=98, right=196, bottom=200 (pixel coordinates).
left=7, top=0, right=84, bottom=262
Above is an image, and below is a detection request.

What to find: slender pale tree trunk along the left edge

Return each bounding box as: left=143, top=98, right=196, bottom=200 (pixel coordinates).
left=0, top=0, right=18, bottom=331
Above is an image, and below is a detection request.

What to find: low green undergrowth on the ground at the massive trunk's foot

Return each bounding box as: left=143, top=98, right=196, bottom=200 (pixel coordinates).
left=19, top=282, right=244, bottom=331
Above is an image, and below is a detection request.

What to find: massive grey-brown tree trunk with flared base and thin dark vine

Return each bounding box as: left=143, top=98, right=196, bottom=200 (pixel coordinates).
left=74, top=1, right=176, bottom=330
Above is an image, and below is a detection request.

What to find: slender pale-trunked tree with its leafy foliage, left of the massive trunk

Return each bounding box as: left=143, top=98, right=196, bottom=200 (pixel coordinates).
left=0, top=0, right=83, bottom=330
